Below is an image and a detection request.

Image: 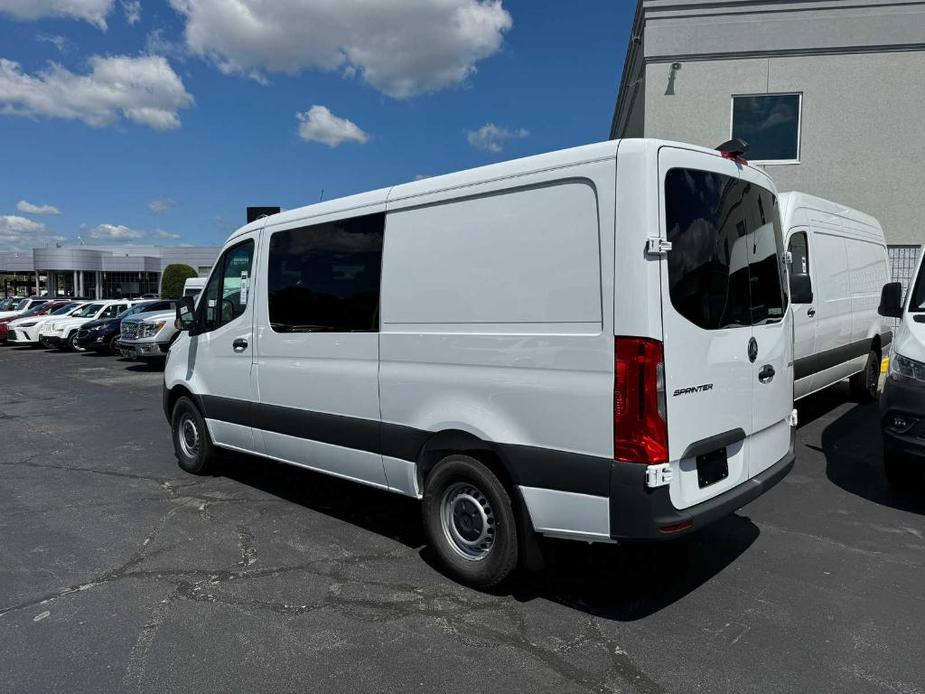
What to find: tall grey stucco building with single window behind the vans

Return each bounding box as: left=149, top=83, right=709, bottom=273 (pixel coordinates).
left=610, top=0, right=925, bottom=280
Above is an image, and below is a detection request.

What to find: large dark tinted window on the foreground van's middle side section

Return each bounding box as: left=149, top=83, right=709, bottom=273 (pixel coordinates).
left=267, top=213, right=385, bottom=333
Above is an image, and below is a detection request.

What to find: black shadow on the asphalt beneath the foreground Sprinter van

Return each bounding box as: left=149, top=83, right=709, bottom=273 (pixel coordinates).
left=221, top=454, right=759, bottom=621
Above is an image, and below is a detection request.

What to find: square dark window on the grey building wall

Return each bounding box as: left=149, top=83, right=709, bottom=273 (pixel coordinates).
left=732, top=94, right=802, bottom=162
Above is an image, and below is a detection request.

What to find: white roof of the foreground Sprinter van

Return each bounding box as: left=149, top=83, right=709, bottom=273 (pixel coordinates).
left=229, top=139, right=748, bottom=239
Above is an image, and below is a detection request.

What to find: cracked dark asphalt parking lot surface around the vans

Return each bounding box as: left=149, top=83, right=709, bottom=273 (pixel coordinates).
left=0, top=347, right=925, bottom=694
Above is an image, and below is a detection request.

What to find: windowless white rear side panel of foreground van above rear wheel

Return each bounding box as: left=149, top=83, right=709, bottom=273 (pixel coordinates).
left=379, top=156, right=616, bottom=536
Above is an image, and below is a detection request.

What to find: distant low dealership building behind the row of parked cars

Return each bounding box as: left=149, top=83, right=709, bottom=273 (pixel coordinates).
left=0, top=246, right=221, bottom=299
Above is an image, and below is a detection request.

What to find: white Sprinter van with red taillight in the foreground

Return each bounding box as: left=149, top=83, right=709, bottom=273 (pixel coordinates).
left=164, top=140, right=794, bottom=586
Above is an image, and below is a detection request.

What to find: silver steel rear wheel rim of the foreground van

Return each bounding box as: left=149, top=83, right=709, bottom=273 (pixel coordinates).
left=440, top=482, right=497, bottom=561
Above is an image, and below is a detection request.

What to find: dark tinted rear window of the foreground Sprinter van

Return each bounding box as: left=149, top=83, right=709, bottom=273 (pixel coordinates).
left=665, top=169, right=787, bottom=330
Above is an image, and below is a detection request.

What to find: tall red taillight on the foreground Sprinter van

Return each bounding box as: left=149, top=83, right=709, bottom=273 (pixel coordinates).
left=613, top=337, right=668, bottom=465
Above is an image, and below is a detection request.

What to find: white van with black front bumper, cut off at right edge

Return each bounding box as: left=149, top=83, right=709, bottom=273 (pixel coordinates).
left=880, top=251, right=925, bottom=491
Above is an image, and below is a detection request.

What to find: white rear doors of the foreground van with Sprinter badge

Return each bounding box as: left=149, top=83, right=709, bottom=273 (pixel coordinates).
left=659, top=147, right=792, bottom=508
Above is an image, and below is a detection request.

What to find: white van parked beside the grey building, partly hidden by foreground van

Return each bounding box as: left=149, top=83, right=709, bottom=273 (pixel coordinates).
left=780, top=193, right=893, bottom=401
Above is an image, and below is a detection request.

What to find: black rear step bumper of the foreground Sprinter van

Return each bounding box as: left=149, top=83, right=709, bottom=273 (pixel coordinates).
left=610, top=429, right=796, bottom=542
